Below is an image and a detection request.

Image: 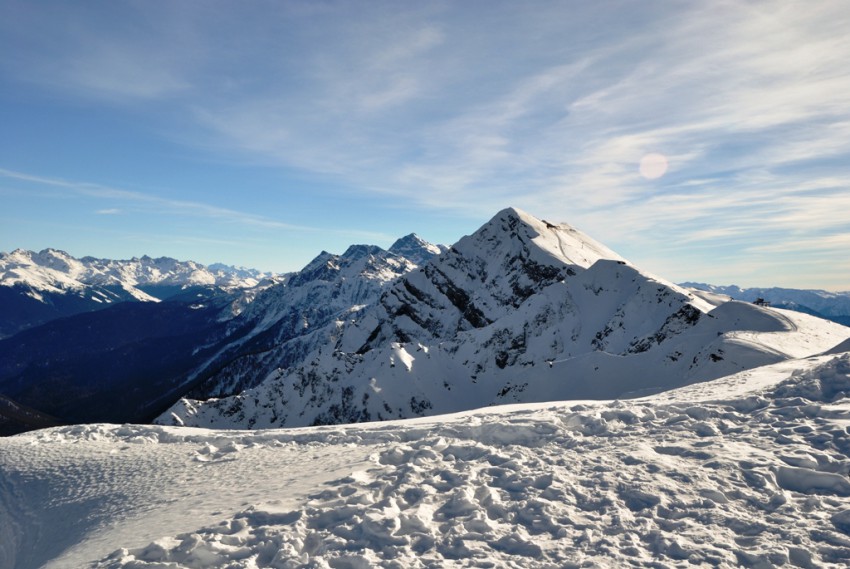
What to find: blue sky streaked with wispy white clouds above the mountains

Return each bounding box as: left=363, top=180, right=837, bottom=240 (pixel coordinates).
left=0, top=0, right=850, bottom=290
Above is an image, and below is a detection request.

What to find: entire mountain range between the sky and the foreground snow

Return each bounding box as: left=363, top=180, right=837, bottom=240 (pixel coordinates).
left=0, top=217, right=850, bottom=434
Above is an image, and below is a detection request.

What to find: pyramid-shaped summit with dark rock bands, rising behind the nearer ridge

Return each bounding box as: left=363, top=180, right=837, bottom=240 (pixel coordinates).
left=361, top=208, right=644, bottom=342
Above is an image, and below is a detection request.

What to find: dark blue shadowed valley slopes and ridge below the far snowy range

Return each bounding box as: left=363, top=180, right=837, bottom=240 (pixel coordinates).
left=0, top=233, right=444, bottom=432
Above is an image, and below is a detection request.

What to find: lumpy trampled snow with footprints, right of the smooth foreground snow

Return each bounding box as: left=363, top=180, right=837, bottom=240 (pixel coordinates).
left=97, top=357, right=850, bottom=569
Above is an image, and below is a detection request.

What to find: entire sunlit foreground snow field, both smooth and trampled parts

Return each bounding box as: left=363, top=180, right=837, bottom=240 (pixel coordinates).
left=0, top=353, right=850, bottom=569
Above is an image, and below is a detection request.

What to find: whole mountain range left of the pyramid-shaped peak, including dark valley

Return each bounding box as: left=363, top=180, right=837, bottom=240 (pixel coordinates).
left=0, top=234, right=445, bottom=434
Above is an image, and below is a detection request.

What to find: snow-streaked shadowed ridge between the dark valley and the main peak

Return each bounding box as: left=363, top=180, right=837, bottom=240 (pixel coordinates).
left=171, top=240, right=441, bottom=398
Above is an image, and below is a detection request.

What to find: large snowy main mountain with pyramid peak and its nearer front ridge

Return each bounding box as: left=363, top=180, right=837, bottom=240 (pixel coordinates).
left=158, top=209, right=850, bottom=428
